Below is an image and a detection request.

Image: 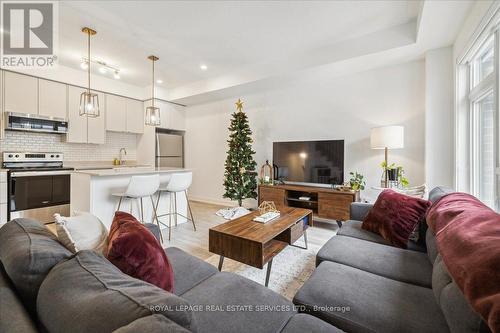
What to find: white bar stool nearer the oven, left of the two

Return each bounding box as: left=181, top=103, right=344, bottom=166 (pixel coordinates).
left=111, top=174, right=163, bottom=242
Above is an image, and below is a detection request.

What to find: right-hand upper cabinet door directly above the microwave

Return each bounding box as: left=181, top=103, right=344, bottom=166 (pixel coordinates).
left=38, top=79, right=68, bottom=120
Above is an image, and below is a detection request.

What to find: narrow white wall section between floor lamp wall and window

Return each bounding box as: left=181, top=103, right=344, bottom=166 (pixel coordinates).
left=425, top=47, right=454, bottom=188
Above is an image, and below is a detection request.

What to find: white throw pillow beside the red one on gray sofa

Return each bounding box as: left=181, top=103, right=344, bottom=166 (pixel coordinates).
left=54, top=212, right=108, bottom=253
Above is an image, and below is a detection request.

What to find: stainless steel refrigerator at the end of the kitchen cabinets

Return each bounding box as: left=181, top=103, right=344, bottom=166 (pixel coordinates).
left=156, top=130, right=184, bottom=168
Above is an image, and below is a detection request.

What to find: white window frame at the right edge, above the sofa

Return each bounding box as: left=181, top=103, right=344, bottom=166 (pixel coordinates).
left=455, top=4, right=500, bottom=211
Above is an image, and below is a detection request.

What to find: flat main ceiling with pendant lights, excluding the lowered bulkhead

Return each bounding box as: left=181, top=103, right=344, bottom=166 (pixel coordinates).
left=59, top=1, right=420, bottom=88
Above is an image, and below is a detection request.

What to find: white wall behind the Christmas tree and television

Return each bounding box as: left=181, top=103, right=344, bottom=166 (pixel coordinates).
left=186, top=61, right=425, bottom=204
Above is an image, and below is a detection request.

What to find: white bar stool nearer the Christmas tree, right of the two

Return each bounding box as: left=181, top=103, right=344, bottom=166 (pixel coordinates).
left=156, top=172, right=196, bottom=240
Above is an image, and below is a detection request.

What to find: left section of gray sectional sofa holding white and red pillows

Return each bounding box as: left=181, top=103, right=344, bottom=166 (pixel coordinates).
left=0, top=219, right=340, bottom=333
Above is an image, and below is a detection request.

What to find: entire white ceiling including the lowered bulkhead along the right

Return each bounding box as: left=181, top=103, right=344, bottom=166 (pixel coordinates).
left=59, top=0, right=474, bottom=104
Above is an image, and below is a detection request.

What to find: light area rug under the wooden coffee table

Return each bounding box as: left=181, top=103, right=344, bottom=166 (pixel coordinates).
left=206, top=241, right=316, bottom=300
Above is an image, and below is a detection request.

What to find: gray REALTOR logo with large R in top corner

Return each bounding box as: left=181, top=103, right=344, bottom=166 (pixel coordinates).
left=1, top=1, right=58, bottom=67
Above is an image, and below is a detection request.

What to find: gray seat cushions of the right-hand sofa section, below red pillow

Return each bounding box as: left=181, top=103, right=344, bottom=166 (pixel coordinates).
left=294, top=187, right=489, bottom=333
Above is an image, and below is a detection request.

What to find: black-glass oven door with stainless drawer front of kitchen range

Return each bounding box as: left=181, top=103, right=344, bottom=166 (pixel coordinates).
left=9, top=172, right=70, bottom=223
